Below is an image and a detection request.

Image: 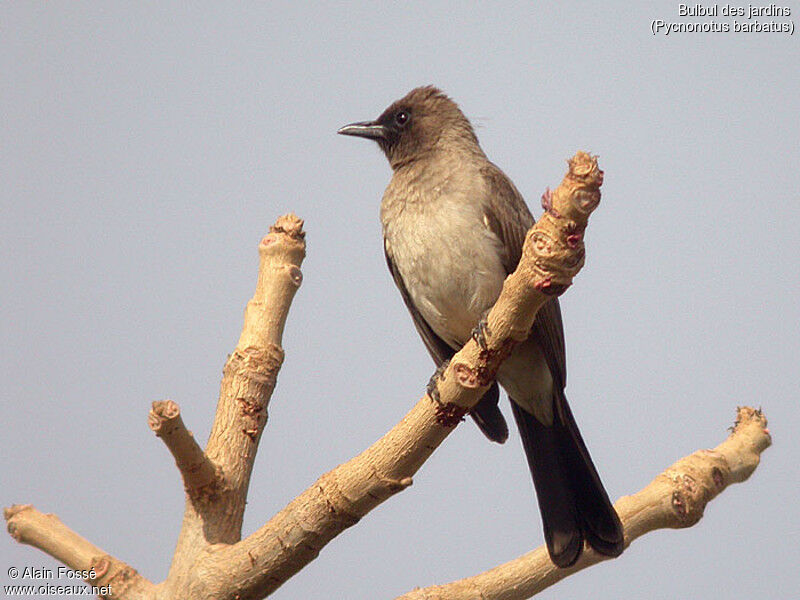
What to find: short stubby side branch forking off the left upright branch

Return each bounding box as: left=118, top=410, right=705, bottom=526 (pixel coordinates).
left=147, top=400, right=221, bottom=497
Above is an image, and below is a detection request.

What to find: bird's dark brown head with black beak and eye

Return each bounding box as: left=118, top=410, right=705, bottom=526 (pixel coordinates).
left=338, top=85, right=479, bottom=169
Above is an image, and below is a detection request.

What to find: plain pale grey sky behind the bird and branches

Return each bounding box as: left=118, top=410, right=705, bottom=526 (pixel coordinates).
left=0, top=2, right=800, bottom=600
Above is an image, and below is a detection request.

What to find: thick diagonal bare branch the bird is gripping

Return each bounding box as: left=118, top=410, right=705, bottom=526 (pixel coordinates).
left=195, top=152, right=603, bottom=599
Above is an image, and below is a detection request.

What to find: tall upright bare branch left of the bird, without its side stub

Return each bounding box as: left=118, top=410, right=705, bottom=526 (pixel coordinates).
left=166, top=214, right=305, bottom=597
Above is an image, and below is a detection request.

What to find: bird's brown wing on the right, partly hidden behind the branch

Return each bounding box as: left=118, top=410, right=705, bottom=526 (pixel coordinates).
left=482, top=163, right=567, bottom=388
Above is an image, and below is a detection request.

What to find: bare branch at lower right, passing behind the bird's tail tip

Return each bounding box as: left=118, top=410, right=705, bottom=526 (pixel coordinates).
left=397, top=407, right=772, bottom=600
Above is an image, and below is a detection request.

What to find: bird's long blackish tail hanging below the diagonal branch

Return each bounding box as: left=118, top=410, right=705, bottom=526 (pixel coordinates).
left=511, top=390, right=625, bottom=567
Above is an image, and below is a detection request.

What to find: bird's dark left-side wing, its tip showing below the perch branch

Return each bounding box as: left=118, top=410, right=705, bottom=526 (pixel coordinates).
left=383, top=240, right=508, bottom=444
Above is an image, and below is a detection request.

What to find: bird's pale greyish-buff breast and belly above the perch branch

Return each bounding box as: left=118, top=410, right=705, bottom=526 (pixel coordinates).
left=381, top=159, right=506, bottom=348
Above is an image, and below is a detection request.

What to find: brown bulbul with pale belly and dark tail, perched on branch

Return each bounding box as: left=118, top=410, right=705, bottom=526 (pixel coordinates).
left=337, top=86, right=624, bottom=568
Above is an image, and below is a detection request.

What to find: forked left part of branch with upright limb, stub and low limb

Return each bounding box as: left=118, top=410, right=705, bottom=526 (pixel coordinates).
left=5, top=215, right=305, bottom=600
